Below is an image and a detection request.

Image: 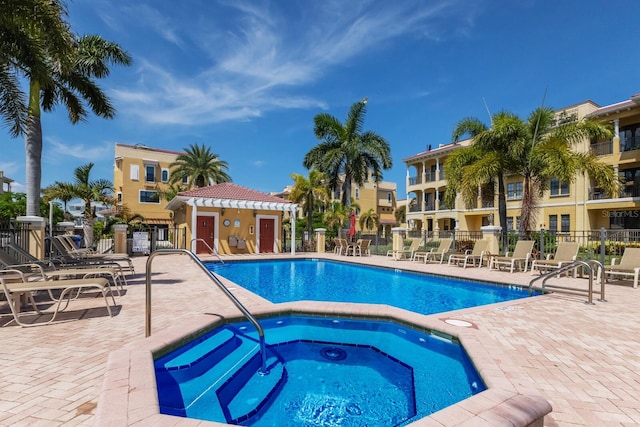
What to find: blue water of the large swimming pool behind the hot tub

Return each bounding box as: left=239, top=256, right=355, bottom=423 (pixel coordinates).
left=207, top=260, right=529, bottom=314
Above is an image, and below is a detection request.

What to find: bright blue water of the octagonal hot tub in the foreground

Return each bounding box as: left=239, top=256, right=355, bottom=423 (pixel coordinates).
left=154, top=316, right=486, bottom=427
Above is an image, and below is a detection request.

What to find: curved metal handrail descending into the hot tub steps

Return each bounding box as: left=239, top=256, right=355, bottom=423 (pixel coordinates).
left=144, top=249, right=268, bottom=374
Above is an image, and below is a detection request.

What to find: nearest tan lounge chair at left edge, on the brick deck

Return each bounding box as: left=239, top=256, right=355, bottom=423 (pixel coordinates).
left=0, top=270, right=116, bottom=327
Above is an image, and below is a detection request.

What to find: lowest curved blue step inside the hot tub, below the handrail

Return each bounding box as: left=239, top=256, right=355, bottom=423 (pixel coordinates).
left=216, top=350, right=287, bottom=424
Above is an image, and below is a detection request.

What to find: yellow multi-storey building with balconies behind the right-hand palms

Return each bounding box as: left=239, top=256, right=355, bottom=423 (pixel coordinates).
left=403, top=94, right=640, bottom=233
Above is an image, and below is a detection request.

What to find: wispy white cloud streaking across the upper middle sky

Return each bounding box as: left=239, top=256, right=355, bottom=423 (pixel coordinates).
left=110, top=0, right=473, bottom=125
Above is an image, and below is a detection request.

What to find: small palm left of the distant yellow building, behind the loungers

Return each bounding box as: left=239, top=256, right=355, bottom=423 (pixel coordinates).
left=71, top=163, right=113, bottom=248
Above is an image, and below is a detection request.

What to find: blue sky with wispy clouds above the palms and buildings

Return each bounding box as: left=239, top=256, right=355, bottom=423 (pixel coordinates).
left=0, top=0, right=640, bottom=198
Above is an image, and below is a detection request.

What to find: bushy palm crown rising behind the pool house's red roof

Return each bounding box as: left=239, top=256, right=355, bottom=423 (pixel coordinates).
left=169, top=144, right=231, bottom=188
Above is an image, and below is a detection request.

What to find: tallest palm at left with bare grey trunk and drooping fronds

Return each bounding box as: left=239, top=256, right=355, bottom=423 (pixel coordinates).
left=25, top=34, right=131, bottom=219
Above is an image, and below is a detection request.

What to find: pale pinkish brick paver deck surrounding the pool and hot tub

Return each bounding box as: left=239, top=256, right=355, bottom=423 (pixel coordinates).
left=0, top=254, right=640, bottom=426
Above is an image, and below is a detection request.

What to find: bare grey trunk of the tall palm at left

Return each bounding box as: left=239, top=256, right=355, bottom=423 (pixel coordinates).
left=24, top=115, right=42, bottom=216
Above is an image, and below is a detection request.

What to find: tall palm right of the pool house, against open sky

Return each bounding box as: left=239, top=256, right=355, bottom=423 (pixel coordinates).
left=303, top=98, right=392, bottom=207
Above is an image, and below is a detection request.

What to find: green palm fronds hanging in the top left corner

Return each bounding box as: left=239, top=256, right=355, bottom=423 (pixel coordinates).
left=0, top=0, right=71, bottom=137
